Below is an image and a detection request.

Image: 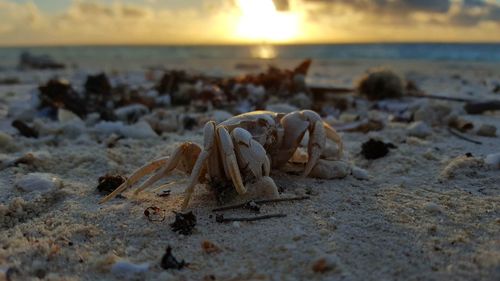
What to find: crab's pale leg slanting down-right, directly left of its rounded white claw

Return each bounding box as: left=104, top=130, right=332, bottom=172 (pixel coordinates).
left=217, top=127, right=247, bottom=194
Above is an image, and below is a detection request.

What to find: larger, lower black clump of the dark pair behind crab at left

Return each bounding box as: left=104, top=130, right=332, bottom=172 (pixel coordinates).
left=38, top=79, right=87, bottom=118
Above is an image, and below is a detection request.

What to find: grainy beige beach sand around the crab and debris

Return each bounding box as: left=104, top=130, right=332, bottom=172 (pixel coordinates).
left=0, top=58, right=500, bottom=280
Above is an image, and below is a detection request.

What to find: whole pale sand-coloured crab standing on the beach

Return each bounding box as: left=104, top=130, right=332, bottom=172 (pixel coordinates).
left=100, top=110, right=343, bottom=209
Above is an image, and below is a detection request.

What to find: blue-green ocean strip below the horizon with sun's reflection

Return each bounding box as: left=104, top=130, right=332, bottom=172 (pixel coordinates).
left=0, top=43, right=500, bottom=69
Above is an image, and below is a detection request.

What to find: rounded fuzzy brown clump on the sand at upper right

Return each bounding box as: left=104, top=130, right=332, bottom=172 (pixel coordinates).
left=356, top=69, right=404, bottom=100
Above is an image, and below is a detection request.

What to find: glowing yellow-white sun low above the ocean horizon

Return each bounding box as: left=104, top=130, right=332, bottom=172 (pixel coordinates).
left=236, top=0, right=299, bottom=43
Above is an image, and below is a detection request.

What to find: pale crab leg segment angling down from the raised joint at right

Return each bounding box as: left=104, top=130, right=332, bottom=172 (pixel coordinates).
left=303, top=120, right=326, bottom=177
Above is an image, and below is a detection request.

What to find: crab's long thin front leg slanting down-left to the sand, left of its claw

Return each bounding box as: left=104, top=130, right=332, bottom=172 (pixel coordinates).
left=182, top=121, right=216, bottom=209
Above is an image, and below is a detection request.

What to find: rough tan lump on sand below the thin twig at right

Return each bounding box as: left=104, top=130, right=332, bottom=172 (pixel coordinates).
left=440, top=154, right=485, bottom=180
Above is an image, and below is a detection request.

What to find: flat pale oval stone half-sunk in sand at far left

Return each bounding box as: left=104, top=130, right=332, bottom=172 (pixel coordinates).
left=14, top=172, right=63, bottom=193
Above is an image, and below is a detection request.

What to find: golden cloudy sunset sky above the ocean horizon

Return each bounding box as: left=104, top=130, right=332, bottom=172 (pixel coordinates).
left=0, top=0, right=500, bottom=46
